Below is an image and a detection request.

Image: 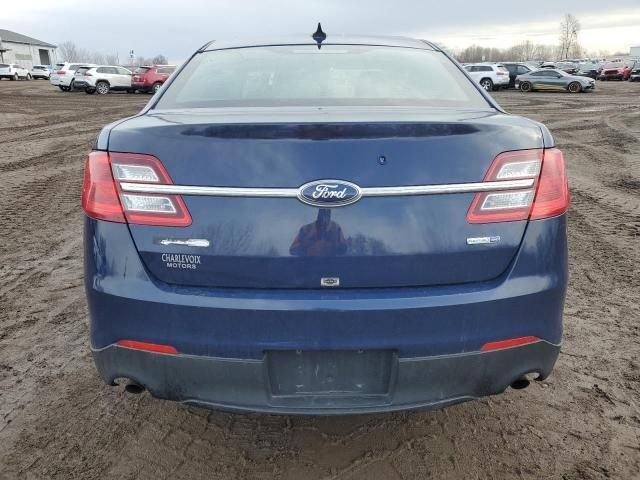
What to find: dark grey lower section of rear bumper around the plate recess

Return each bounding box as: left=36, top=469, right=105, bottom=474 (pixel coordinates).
left=93, top=341, right=559, bottom=415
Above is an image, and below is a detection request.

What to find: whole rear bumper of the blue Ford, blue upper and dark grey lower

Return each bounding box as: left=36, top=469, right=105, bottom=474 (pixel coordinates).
left=85, top=215, right=567, bottom=414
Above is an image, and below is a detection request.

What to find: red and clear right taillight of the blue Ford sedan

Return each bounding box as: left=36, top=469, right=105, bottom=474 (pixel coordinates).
left=467, top=148, right=569, bottom=223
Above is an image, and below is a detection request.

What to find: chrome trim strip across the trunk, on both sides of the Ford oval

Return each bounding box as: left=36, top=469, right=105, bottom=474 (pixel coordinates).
left=120, top=178, right=535, bottom=198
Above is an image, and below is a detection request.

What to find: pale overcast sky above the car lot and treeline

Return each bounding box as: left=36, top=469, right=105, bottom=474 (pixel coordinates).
left=0, top=0, right=640, bottom=62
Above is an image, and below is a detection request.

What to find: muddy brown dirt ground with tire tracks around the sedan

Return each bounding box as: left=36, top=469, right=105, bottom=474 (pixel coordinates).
left=0, top=81, right=640, bottom=480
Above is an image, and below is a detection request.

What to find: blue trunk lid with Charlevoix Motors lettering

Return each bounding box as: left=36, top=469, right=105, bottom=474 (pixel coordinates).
left=109, top=108, right=544, bottom=288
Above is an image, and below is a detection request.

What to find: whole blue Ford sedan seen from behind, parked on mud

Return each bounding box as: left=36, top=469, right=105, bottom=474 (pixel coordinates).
left=82, top=28, right=569, bottom=414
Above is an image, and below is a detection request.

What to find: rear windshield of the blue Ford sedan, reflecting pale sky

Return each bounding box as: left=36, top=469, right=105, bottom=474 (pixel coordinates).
left=156, top=44, right=488, bottom=108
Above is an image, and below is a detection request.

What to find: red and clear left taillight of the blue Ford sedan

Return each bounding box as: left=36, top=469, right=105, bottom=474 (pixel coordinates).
left=82, top=152, right=191, bottom=227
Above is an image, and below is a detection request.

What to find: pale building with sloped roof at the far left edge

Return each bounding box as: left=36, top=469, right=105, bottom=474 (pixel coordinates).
left=0, top=29, right=58, bottom=68
